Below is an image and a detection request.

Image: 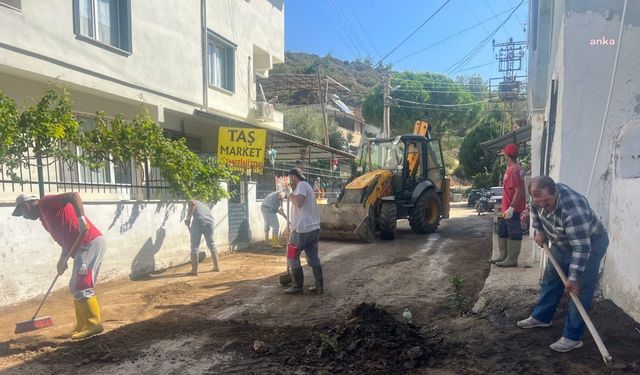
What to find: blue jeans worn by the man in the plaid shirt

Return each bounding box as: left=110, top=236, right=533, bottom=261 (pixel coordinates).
left=531, top=232, right=609, bottom=340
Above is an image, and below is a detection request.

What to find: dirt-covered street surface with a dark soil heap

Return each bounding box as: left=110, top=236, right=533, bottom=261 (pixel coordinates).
left=0, top=206, right=640, bottom=374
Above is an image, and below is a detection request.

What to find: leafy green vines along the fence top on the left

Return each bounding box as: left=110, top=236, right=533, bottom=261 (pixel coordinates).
left=0, top=88, right=237, bottom=202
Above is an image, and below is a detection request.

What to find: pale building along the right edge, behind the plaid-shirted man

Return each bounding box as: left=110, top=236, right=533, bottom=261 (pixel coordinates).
left=529, top=0, right=640, bottom=321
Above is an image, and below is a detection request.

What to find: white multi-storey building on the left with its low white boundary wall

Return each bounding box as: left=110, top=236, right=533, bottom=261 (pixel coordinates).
left=0, top=0, right=284, bottom=306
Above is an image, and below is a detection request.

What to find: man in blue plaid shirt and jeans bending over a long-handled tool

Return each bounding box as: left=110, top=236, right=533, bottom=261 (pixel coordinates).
left=518, top=176, right=609, bottom=352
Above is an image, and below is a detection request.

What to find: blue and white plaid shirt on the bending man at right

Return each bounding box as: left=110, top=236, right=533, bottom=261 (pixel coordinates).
left=531, top=184, right=604, bottom=281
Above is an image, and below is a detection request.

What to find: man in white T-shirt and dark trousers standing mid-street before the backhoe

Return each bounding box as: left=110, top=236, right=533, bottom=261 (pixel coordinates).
left=284, top=168, right=324, bottom=294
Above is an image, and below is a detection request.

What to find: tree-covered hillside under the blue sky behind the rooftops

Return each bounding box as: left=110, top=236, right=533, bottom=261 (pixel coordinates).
left=269, top=51, right=382, bottom=107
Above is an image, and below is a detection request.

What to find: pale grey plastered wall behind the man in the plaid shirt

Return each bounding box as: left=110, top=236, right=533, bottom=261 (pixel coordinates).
left=531, top=0, right=640, bottom=321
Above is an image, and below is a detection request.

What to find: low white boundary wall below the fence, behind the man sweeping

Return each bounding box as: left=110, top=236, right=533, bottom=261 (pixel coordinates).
left=0, top=182, right=230, bottom=307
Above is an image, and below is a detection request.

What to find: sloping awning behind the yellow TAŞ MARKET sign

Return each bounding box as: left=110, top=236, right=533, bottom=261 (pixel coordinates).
left=194, top=110, right=355, bottom=161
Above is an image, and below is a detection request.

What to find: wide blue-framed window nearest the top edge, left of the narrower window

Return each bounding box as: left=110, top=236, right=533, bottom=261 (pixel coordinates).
left=73, top=0, right=131, bottom=52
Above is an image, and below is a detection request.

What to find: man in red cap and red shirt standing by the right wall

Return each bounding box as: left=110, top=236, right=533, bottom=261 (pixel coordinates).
left=489, top=143, right=525, bottom=267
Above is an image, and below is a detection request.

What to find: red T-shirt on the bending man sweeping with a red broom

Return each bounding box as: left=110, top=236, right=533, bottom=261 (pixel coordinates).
left=38, top=194, right=102, bottom=255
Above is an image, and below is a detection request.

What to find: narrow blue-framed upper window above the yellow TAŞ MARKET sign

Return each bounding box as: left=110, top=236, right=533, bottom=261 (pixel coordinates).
left=207, top=32, right=237, bottom=92
